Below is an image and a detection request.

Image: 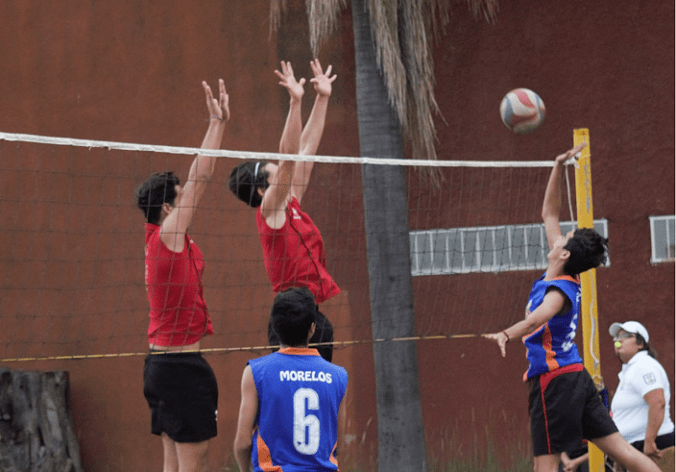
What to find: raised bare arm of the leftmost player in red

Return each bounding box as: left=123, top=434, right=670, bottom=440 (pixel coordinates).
left=160, top=79, right=230, bottom=252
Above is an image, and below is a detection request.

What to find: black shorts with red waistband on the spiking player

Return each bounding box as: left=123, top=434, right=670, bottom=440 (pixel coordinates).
left=529, top=366, right=617, bottom=456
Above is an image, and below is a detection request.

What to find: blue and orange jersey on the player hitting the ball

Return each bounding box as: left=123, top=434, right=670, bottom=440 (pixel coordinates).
left=523, top=275, right=582, bottom=380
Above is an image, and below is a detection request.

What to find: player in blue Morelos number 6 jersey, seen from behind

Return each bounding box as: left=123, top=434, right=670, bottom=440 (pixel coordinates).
left=234, top=287, right=347, bottom=472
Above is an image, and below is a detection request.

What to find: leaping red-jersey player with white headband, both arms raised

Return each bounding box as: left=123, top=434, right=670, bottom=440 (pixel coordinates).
left=229, top=59, right=340, bottom=361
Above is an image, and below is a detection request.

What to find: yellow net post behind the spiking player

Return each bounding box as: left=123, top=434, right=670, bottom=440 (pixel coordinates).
left=573, top=128, right=604, bottom=472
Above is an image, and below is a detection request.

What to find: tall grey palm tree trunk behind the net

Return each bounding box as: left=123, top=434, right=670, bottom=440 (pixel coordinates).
left=352, top=0, right=427, bottom=472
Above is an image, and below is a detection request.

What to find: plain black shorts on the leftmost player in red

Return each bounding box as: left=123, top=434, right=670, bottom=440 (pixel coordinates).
left=143, top=352, right=218, bottom=443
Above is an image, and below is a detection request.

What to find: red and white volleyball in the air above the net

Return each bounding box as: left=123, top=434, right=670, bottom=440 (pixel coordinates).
left=500, top=88, right=545, bottom=134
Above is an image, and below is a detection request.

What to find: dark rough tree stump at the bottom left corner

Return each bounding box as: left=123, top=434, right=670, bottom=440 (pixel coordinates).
left=0, top=367, right=83, bottom=472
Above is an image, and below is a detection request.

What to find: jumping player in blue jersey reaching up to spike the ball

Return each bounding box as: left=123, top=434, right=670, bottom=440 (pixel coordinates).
left=484, top=143, right=659, bottom=472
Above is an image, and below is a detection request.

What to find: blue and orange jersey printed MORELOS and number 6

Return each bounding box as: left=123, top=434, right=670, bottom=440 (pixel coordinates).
left=249, top=348, right=347, bottom=472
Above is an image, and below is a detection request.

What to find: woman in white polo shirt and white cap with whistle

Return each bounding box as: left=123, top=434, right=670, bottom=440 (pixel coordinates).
left=610, top=321, right=674, bottom=460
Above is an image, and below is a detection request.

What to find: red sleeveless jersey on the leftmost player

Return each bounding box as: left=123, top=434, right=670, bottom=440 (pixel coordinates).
left=145, top=223, right=214, bottom=346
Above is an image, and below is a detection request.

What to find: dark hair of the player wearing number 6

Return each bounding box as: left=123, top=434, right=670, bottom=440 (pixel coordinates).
left=270, top=287, right=317, bottom=347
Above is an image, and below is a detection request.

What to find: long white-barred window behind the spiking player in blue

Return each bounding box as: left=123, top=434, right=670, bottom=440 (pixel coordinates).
left=410, top=217, right=608, bottom=276
